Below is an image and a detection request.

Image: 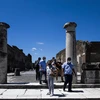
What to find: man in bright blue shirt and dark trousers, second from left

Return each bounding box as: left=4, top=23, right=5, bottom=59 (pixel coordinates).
left=39, top=57, right=46, bottom=84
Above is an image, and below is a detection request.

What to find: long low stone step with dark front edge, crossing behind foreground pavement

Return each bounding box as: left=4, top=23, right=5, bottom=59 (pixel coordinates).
left=0, top=83, right=100, bottom=89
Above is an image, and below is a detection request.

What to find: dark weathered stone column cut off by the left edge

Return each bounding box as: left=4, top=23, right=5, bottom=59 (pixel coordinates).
left=0, top=22, right=10, bottom=84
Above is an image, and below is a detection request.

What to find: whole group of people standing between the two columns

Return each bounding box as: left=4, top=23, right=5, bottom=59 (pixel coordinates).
left=35, top=57, right=76, bottom=96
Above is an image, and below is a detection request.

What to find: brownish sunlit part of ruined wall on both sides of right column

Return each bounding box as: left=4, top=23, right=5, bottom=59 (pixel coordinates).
left=56, top=40, right=86, bottom=72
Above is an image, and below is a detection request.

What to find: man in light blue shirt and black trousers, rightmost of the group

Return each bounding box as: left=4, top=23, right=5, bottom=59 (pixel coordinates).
left=62, top=57, right=76, bottom=92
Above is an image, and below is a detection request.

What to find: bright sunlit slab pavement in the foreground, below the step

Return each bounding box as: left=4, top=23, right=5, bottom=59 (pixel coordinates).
left=0, top=88, right=100, bottom=100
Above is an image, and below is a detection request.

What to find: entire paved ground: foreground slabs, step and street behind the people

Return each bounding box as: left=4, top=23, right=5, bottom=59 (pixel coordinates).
left=5, top=71, right=100, bottom=100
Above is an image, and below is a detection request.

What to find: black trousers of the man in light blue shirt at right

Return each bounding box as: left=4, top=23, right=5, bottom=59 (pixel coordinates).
left=63, top=74, right=72, bottom=91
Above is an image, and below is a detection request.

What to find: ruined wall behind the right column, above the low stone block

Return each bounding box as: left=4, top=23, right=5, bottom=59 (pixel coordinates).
left=56, top=40, right=100, bottom=72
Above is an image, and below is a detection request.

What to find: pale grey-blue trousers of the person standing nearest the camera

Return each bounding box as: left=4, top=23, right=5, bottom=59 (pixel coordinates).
left=47, top=76, right=54, bottom=94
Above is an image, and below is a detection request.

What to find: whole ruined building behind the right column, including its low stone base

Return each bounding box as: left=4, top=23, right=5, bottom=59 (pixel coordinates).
left=56, top=40, right=100, bottom=83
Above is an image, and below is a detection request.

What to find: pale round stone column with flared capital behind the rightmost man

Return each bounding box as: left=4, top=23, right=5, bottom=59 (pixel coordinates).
left=64, top=22, right=77, bottom=83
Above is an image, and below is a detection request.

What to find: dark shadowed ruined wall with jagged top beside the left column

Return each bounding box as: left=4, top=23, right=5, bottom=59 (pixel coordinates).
left=7, top=44, right=32, bottom=72
